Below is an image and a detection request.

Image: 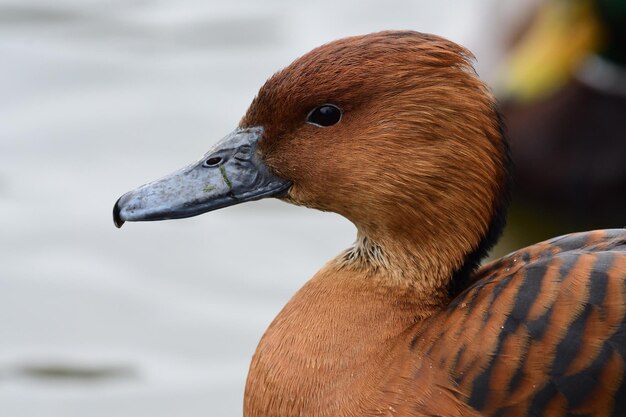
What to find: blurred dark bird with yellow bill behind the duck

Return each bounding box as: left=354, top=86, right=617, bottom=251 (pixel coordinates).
left=492, top=0, right=626, bottom=250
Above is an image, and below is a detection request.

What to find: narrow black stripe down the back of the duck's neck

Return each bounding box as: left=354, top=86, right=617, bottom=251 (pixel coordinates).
left=448, top=108, right=513, bottom=298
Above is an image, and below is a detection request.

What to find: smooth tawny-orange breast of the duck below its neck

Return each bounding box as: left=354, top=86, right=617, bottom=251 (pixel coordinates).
left=244, top=246, right=450, bottom=417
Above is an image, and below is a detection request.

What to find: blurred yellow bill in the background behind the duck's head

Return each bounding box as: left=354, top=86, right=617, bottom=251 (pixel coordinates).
left=498, top=0, right=601, bottom=102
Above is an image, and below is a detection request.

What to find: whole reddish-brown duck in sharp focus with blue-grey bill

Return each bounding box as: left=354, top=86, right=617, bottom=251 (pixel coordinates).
left=113, top=31, right=626, bottom=417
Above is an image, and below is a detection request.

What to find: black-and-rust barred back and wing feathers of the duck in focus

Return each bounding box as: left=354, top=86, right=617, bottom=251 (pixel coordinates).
left=411, top=229, right=626, bottom=416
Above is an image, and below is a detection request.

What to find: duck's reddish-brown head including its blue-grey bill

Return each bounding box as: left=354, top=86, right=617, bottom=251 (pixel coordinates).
left=114, top=31, right=508, bottom=282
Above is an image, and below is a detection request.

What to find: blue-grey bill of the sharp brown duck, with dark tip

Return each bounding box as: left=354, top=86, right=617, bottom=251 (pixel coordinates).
left=113, top=127, right=291, bottom=227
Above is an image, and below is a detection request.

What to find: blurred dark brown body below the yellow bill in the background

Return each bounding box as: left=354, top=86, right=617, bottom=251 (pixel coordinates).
left=503, top=68, right=626, bottom=228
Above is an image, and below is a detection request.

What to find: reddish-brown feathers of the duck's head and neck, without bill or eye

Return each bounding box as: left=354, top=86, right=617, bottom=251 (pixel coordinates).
left=241, top=32, right=508, bottom=296
